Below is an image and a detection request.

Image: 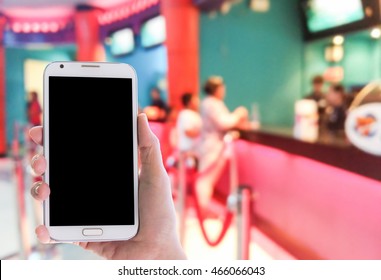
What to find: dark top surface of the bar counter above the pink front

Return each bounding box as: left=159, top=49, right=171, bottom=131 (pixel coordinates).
left=240, top=128, right=381, bottom=181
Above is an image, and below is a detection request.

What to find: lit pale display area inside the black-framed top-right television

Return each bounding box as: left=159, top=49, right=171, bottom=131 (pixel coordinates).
left=306, top=0, right=365, bottom=32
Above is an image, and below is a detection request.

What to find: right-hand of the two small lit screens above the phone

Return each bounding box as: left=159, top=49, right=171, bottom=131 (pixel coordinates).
left=140, top=16, right=166, bottom=48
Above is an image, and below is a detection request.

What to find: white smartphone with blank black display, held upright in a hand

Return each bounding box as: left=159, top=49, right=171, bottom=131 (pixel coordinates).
left=43, top=62, right=139, bottom=242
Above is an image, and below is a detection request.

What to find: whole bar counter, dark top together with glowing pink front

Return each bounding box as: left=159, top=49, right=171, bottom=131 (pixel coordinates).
left=153, top=122, right=381, bottom=259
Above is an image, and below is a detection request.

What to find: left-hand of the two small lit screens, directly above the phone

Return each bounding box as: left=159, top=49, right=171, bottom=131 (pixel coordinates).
left=110, top=28, right=135, bottom=56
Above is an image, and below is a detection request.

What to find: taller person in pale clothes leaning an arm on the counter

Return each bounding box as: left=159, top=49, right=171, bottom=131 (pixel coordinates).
left=196, top=76, right=248, bottom=207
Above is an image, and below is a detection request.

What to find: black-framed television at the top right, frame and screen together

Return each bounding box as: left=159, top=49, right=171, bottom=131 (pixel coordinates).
left=300, top=0, right=380, bottom=41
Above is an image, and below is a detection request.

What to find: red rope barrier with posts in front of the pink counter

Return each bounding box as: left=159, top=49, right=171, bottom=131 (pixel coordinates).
left=167, top=133, right=252, bottom=260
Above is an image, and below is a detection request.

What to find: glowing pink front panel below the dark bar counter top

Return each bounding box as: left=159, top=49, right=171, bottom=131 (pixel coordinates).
left=236, top=140, right=381, bottom=259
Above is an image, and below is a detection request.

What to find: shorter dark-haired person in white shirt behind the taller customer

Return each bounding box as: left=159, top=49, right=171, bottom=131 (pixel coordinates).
left=176, top=93, right=202, bottom=155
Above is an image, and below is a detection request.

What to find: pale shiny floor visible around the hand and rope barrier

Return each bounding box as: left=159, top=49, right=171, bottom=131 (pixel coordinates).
left=0, top=159, right=293, bottom=260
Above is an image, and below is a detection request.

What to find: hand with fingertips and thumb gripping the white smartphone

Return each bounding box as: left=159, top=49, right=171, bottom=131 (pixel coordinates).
left=30, top=114, right=186, bottom=259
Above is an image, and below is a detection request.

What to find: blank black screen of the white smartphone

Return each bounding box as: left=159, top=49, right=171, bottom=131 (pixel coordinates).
left=45, top=76, right=137, bottom=226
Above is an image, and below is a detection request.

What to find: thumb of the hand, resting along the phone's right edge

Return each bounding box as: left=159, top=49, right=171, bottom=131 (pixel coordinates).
left=138, top=114, right=164, bottom=168
